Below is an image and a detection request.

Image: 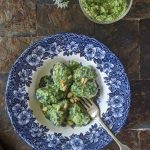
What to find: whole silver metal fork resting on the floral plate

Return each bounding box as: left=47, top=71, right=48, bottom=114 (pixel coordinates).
left=80, top=98, right=131, bottom=150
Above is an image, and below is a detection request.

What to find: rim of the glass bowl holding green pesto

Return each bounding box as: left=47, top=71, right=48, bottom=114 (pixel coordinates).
left=79, top=0, right=133, bottom=24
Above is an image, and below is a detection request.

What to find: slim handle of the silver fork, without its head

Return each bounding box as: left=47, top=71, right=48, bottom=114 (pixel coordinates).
left=96, top=117, right=131, bottom=150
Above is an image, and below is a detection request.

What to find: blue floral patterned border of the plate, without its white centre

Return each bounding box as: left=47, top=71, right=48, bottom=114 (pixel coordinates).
left=6, top=33, right=130, bottom=150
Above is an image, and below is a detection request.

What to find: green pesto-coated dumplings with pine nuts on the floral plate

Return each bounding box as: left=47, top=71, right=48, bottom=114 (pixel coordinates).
left=35, top=61, right=98, bottom=127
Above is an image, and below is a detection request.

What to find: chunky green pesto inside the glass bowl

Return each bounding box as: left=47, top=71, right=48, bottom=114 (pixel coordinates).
left=80, top=0, right=128, bottom=22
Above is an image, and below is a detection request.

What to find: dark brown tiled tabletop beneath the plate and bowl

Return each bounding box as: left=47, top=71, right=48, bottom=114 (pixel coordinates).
left=0, top=0, right=150, bottom=150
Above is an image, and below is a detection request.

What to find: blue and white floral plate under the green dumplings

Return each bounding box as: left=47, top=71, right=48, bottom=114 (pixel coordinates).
left=6, top=33, right=130, bottom=150
